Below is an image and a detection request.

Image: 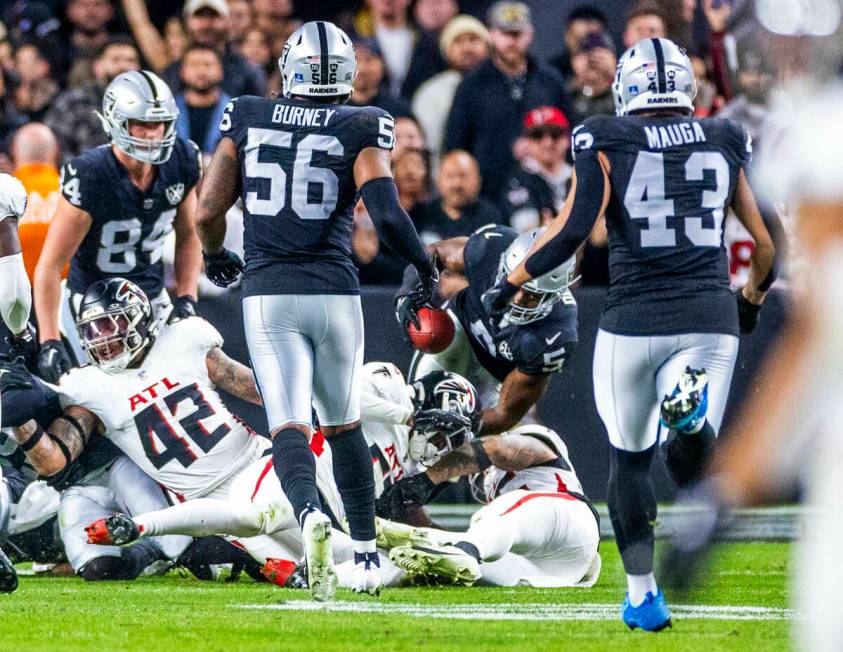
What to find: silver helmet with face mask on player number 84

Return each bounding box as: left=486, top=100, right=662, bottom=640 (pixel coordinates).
left=97, top=70, right=179, bottom=165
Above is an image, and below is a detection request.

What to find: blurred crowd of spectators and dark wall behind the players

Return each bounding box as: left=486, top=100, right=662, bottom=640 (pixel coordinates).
left=0, top=0, right=787, bottom=501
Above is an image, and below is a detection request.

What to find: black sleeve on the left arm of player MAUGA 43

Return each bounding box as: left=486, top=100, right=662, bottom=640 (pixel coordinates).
left=524, top=150, right=606, bottom=278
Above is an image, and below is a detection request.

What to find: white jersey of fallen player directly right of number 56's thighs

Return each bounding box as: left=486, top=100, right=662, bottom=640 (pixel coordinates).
left=360, top=362, right=422, bottom=496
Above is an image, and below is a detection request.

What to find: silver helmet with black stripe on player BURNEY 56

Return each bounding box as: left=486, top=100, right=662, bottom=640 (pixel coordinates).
left=278, top=20, right=357, bottom=97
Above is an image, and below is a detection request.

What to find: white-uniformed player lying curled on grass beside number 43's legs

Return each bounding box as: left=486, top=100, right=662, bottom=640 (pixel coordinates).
left=378, top=424, right=601, bottom=587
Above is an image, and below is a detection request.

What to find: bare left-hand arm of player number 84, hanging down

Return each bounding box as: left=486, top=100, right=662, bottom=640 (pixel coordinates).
left=35, top=197, right=92, bottom=342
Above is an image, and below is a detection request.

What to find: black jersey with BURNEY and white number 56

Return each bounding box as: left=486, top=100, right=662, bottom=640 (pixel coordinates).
left=220, top=97, right=394, bottom=296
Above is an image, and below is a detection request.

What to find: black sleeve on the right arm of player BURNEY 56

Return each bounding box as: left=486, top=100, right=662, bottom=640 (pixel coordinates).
left=360, top=177, right=430, bottom=272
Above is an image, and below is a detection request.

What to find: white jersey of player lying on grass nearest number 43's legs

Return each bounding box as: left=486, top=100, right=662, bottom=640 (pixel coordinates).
left=483, top=426, right=583, bottom=502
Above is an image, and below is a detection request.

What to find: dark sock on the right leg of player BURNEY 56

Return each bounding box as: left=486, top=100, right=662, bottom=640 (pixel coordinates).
left=327, top=426, right=375, bottom=553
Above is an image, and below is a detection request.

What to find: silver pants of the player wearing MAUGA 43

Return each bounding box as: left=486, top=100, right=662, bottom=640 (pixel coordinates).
left=593, top=329, right=738, bottom=453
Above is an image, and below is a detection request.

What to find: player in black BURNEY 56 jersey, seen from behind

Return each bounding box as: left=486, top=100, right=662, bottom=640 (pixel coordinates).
left=197, top=21, right=437, bottom=600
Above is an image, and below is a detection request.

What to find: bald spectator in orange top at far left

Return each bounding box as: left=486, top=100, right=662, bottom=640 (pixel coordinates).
left=11, top=122, right=62, bottom=280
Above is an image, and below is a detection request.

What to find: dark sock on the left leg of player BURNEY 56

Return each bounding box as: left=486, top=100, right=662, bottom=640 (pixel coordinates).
left=272, top=428, right=322, bottom=525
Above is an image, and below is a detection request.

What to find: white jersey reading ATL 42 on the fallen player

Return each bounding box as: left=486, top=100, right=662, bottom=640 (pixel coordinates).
left=57, top=317, right=267, bottom=499
